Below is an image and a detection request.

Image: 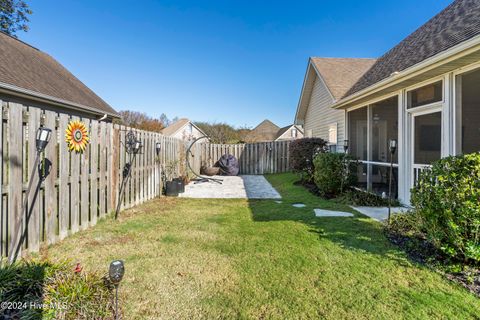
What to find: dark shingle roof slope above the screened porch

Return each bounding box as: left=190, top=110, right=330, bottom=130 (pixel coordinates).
left=344, top=0, right=480, bottom=97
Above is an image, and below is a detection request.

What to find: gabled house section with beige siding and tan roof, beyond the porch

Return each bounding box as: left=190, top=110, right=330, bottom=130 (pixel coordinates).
left=295, top=58, right=375, bottom=150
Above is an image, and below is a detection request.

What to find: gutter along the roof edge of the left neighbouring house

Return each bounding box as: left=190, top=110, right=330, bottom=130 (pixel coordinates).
left=0, top=82, right=120, bottom=119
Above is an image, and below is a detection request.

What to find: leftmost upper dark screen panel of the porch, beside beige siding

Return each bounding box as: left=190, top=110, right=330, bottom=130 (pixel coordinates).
left=348, top=107, right=368, bottom=160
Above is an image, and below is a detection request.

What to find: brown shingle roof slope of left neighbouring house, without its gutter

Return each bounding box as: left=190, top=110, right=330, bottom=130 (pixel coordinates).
left=0, top=32, right=118, bottom=116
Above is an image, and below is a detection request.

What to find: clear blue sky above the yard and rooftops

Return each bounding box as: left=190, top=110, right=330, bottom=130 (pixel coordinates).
left=18, top=0, right=451, bottom=126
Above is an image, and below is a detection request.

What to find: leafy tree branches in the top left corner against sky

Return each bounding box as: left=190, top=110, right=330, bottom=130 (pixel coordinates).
left=0, top=0, right=32, bottom=38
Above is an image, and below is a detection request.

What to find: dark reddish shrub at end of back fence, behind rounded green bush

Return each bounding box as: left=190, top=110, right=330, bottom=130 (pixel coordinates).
left=289, top=138, right=327, bottom=182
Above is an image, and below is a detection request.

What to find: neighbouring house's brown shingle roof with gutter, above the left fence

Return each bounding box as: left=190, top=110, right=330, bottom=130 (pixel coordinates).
left=0, top=32, right=120, bottom=121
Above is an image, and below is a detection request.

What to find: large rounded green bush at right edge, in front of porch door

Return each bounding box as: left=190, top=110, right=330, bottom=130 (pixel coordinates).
left=411, top=153, right=480, bottom=264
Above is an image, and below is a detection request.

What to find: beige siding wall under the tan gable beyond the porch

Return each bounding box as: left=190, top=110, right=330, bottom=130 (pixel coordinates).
left=305, top=76, right=345, bottom=150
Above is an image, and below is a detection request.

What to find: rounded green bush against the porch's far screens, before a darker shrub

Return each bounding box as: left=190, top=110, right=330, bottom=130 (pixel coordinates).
left=313, top=153, right=357, bottom=198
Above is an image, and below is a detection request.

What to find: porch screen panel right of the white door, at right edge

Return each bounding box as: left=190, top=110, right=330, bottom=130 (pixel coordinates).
left=459, top=70, right=480, bottom=153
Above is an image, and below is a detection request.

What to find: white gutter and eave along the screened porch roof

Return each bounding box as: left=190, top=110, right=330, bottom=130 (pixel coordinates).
left=332, top=35, right=480, bottom=109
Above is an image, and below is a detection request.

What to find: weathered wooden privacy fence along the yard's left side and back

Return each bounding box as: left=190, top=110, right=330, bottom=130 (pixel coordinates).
left=0, top=101, right=288, bottom=256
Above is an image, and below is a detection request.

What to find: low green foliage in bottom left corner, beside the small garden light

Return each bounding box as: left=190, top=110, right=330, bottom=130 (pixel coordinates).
left=0, top=261, right=114, bottom=319
